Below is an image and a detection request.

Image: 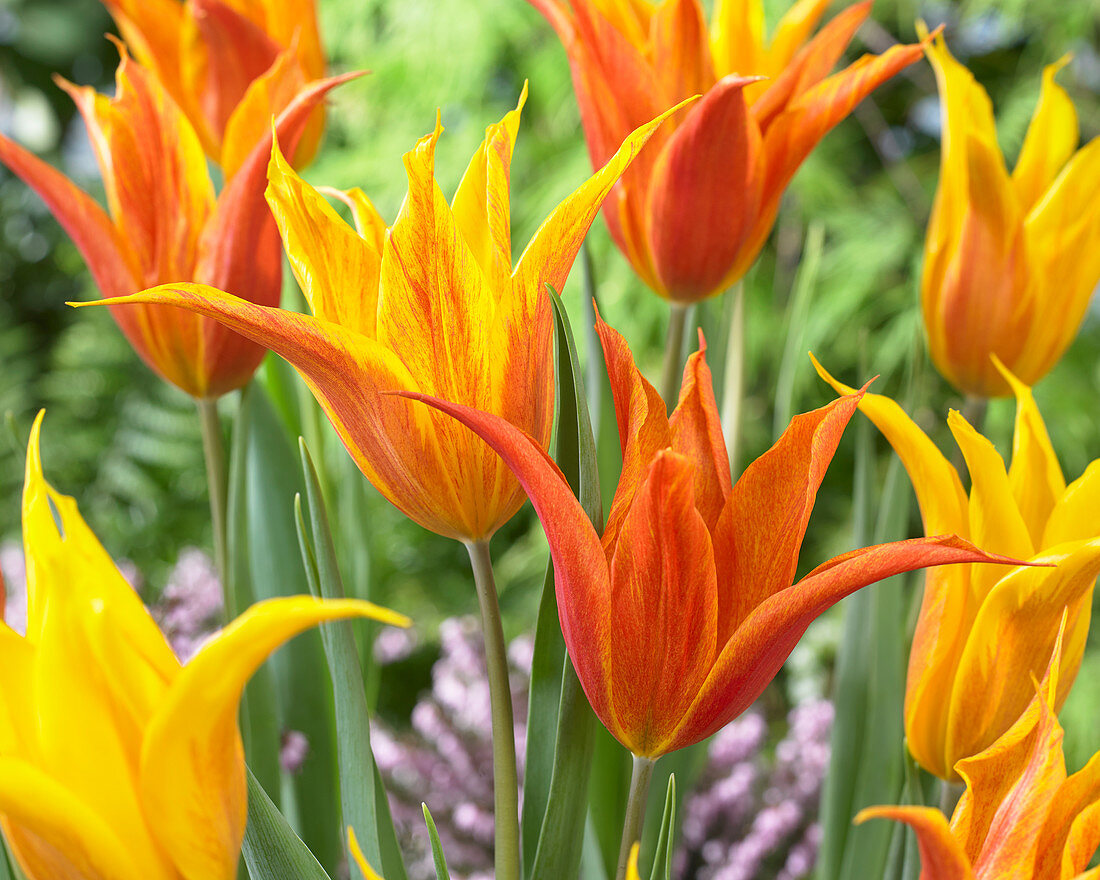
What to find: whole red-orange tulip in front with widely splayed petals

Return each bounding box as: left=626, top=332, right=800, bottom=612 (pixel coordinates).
left=402, top=310, right=1012, bottom=758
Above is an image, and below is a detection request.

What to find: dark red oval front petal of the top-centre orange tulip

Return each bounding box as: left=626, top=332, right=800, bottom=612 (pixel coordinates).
left=646, top=76, right=762, bottom=303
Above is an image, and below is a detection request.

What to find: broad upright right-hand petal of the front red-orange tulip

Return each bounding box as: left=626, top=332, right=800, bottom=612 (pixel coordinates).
left=715, top=392, right=859, bottom=645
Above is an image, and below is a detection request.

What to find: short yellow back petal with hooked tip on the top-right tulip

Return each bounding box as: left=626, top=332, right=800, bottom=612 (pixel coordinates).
left=1012, top=55, right=1077, bottom=213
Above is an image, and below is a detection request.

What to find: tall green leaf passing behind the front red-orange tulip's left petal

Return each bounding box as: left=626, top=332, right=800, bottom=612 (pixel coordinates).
left=521, top=285, right=603, bottom=880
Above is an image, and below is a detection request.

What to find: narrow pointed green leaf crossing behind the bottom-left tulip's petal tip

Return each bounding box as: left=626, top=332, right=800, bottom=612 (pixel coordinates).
left=295, top=439, right=406, bottom=880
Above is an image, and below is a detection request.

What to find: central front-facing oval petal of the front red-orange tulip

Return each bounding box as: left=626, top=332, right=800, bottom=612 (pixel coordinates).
left=612, top=450, right=717, bottom=757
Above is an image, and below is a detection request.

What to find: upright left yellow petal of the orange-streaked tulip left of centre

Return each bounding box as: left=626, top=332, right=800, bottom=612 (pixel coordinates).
left=266, top=131, right=382, bottom=338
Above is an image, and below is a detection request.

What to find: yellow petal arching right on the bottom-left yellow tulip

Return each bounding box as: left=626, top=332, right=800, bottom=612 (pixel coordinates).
left=141, top=596, right=408, bottom=880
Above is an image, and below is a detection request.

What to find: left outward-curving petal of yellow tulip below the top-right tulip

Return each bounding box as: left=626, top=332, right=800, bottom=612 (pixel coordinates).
left=810, top=354, right=969, bottom=538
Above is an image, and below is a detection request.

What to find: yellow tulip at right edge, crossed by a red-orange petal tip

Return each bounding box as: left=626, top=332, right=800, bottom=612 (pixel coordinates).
left=815, top=361, right=1100, bottom=780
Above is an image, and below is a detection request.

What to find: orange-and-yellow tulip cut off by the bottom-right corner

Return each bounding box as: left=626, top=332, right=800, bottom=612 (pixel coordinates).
left=856, top=624, right=1100, bottom=880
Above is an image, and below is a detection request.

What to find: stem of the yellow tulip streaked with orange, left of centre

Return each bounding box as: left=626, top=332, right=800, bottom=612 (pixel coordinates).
left=466, top=540, right=519, bottom=880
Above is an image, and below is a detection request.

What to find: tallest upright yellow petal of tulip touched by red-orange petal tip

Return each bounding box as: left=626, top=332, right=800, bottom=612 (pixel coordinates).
left=993, top=355, right=1066, bottom=548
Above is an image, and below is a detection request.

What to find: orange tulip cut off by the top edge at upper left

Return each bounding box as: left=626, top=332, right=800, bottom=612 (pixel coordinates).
left=102, top=0, right=325, bottom=175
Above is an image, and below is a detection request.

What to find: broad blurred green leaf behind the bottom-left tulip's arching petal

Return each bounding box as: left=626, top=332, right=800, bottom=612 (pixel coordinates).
left=238, top=385, right=344, bottom=870
